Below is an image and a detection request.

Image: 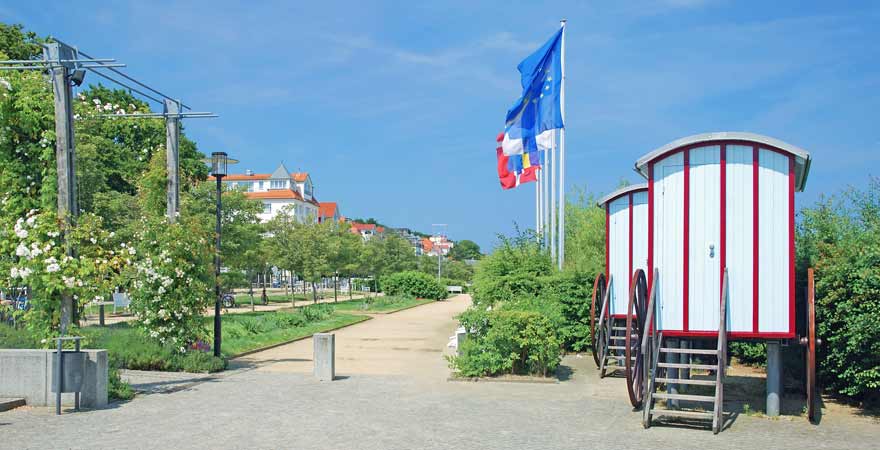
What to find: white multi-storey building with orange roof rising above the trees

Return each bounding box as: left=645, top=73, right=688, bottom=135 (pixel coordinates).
left=209, top=163, right=319, bottom=222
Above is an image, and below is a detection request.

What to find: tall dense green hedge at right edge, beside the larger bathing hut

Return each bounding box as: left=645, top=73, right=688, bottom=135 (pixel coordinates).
left=797, top=178, right=880, bottom=401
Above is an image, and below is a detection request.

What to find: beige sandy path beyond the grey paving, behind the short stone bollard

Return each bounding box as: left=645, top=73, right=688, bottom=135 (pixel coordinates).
left=232, top=295, right=471, bottom=381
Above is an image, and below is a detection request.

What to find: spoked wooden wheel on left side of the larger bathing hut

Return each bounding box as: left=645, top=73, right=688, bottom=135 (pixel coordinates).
left=624, top=269, right=648, bottom=408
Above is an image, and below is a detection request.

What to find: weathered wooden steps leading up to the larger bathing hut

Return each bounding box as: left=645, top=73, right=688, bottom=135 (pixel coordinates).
left=642, top=269, right=727, bottom=434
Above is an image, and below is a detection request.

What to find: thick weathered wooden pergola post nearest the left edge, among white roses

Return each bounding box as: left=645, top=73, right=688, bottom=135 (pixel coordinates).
left=43, top=42, right=78, bottom=336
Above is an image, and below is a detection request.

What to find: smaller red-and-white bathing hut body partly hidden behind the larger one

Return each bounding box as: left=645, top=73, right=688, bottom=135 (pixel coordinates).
left=599, top=184, right=648, bottom=317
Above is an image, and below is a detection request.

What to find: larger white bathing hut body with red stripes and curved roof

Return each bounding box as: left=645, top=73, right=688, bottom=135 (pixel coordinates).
left=632, top=132, right=810, bottom=339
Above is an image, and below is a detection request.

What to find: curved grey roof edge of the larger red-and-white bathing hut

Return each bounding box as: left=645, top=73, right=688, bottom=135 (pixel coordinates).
left=635, top=131, right=811, bottom=191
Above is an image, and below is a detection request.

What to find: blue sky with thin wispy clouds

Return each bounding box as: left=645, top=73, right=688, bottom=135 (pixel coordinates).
left=0, top=0, right=880, bottom=249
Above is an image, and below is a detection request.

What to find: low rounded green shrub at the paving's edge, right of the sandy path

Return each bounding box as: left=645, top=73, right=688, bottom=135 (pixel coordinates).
left=449, top=305, right=562, bottom=377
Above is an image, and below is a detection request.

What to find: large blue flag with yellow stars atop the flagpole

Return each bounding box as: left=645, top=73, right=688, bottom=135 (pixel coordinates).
left=505, top=28, right=565, bottom=144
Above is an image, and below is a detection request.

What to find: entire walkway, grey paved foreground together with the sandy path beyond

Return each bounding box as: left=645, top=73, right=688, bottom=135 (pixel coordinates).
left=0, top=296, right=880, bottom=450
